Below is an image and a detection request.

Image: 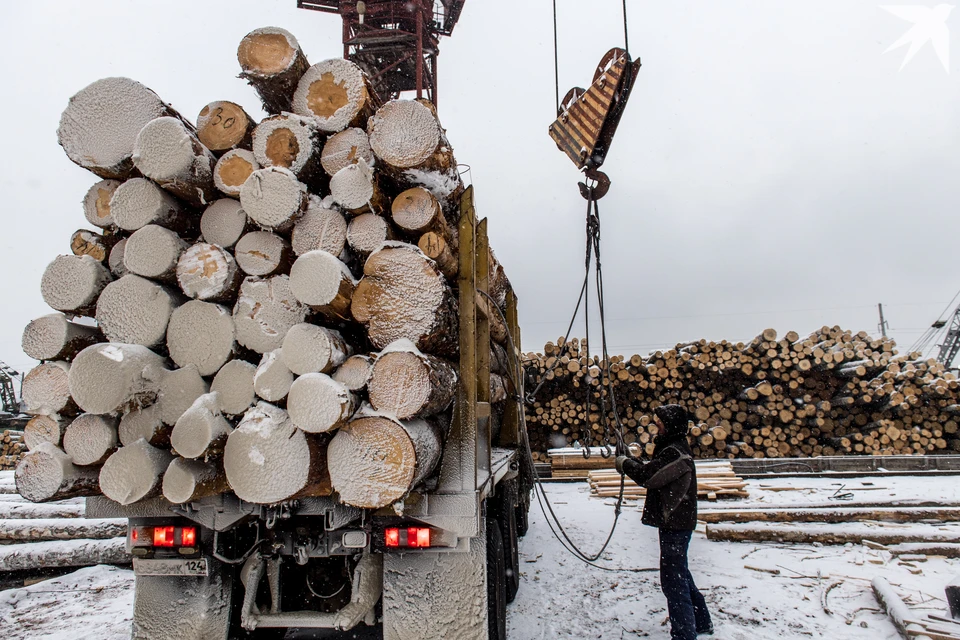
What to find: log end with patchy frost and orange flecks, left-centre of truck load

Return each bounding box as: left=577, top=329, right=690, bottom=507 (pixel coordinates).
left=178, top=242, right=243, bottom=302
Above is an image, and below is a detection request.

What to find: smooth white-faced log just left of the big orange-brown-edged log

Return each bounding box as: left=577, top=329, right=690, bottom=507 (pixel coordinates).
left=290, top=250, right=357, bottom=320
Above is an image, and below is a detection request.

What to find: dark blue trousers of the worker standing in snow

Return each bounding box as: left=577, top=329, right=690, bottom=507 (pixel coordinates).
left=660, top=529, right=712, bottom=640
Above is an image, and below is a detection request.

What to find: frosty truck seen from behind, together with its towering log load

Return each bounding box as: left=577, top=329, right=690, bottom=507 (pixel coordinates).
left=16, top=15, right=533, bottom=640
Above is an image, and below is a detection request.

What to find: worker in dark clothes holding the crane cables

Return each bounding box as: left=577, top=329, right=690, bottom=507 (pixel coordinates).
left=616, top=404, right=713, bottom=640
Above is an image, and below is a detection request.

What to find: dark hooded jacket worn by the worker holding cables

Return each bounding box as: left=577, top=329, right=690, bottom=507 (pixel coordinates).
left=623, top=404, right=697, bottom=531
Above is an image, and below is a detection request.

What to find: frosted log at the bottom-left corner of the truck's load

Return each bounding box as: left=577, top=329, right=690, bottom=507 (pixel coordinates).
left=14, top=442, right=100, bottom=502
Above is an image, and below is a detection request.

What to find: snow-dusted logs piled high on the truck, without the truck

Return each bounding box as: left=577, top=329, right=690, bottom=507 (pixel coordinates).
left=16, top=28, right=509, bottom=509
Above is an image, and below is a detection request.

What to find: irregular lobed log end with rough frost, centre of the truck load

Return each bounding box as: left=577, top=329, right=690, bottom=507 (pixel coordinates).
left=233, top=276, right=309, bottom=353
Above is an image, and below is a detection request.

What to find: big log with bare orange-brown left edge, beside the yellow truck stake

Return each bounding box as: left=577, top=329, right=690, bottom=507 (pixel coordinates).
left=350, top=242, right=459, bottom=355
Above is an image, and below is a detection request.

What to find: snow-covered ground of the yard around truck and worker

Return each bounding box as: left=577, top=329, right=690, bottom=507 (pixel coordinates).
left=0, top=477, right=960, bottom=640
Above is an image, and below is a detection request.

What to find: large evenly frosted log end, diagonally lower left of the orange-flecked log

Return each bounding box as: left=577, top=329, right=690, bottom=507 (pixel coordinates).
left=97, top=273, right=183, bottom=347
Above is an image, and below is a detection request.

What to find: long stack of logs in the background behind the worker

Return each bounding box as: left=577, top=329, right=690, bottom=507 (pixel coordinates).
left=525, top=327, right=960, bottom=461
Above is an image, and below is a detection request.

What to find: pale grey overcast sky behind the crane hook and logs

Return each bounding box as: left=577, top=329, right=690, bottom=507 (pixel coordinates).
left=0, top=0, right=960, bottom=378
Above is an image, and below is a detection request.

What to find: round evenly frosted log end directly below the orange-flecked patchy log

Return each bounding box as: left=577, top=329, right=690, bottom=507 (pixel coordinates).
left=167, top=300, right=237, bottom=376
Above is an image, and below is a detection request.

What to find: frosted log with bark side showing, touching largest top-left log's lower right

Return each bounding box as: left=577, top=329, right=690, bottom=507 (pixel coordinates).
left=133, top=117, right=219, bottom=207
